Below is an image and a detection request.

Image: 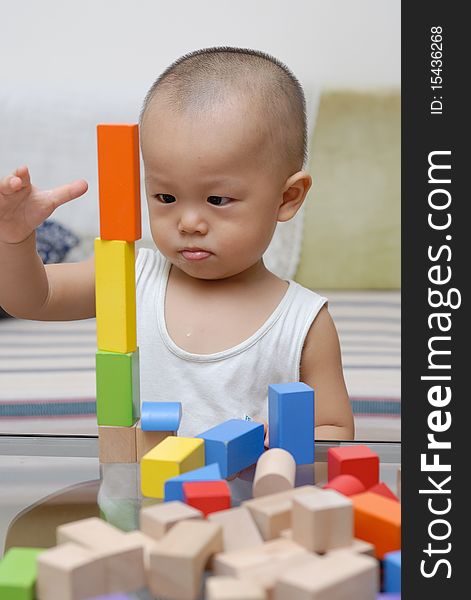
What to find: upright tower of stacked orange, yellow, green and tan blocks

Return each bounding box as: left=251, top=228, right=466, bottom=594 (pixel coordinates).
left=95, top=124, right=141, bottom=462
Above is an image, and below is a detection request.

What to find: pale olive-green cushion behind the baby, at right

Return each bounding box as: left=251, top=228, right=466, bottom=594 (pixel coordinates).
left=295, top=91, right=401, bottom=289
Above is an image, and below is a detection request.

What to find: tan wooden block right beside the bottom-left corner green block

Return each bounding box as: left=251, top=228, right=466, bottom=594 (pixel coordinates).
left=36, top=543, right=107, bottom=600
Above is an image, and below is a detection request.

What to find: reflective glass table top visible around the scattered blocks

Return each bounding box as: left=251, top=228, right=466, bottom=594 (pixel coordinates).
left=0, top=435, right=401, bottom=556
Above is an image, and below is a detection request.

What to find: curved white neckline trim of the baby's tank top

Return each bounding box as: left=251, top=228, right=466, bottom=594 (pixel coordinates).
left=157, top=257, right=298, bottom=362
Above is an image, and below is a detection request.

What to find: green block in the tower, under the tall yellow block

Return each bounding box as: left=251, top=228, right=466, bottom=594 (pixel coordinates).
left=96, top=348, right=140, bottom=427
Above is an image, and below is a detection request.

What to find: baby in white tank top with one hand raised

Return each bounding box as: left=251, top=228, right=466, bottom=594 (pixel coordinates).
left=0, top=47, right=354, bottom=439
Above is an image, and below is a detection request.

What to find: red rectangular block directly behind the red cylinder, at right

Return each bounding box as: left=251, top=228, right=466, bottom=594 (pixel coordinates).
left=327, top=445, right=379, bottom=489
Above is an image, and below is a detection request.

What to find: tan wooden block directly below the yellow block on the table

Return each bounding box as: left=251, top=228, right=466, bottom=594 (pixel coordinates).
left=139, top=500, right=204, bottom=540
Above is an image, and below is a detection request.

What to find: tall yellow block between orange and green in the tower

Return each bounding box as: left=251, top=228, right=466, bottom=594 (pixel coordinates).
left=95, top=238, right=137, bottom=354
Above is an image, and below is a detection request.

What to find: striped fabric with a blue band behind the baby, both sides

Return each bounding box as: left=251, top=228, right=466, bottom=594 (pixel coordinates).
left=0, top=291, right=401, bottom=440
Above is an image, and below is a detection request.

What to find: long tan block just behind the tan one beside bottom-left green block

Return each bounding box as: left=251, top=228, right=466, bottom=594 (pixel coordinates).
left=57, top=517, right=146, bottom=594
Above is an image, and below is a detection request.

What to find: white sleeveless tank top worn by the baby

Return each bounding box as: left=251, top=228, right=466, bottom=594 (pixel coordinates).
left=136, top=248, right=327, bottom=437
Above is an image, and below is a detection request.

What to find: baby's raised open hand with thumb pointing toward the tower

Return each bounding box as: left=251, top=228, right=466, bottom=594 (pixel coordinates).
left=0, top=166, right=88, bottom=244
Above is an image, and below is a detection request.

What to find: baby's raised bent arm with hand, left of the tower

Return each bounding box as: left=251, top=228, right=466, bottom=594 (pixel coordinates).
left=0, top=167, right=95, bottom=321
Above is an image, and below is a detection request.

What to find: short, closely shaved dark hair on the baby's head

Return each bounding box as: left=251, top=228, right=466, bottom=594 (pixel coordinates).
left=139, top=46, right=307, bottom=174
